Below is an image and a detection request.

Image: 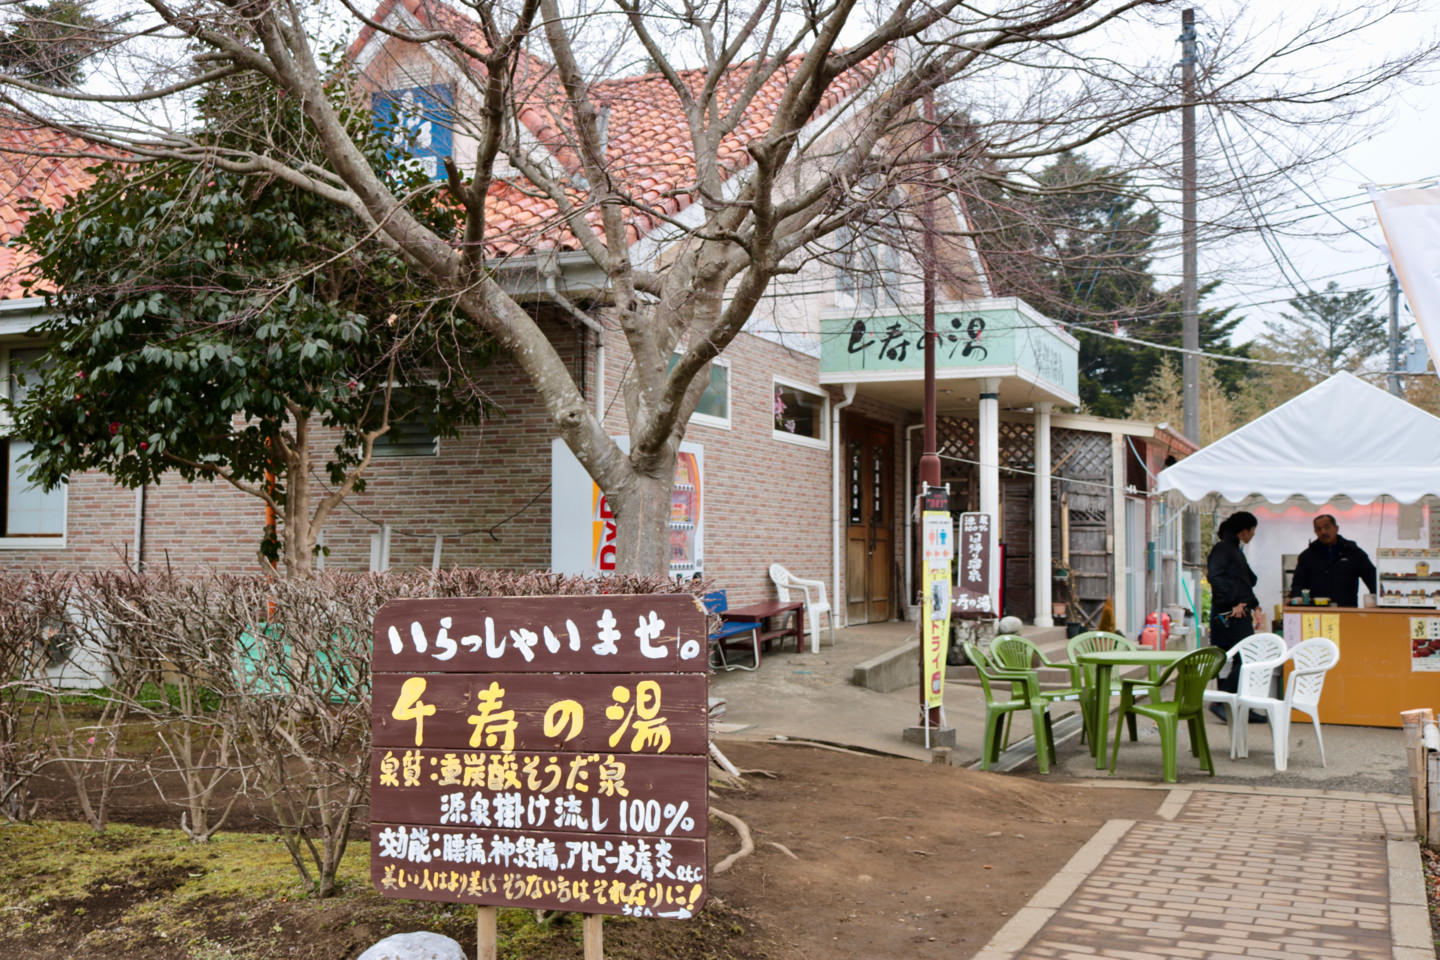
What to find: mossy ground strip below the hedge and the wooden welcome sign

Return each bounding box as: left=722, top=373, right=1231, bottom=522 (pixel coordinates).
left=0, top=822, right=756, bottom=960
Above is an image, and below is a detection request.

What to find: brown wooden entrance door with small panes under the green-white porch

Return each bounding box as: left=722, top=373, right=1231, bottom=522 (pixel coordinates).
left=845, top=417, right=894, bottom=623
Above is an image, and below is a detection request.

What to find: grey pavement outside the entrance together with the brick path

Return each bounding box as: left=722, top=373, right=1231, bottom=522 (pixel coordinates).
left=711, top=623, right=1436, bottom=960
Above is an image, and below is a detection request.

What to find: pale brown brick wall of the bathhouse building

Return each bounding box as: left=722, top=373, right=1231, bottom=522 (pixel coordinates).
left=0, top=321, right=904, bottom=618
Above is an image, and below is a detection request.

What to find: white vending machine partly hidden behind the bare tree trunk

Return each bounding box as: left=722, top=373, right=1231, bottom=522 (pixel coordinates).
left=550, top=436, right=706, bottom=577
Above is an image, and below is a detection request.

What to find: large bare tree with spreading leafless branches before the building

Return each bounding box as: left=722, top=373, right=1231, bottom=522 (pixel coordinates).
left=0, top=0, right=1434, bottom=571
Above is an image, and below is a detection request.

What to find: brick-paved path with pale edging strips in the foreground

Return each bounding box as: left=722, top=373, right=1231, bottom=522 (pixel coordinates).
left=976, top=787, right=1436, bottom=960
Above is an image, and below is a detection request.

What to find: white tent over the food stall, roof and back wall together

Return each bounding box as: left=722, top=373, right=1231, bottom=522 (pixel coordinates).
left=1159, top=373, right=1440, bottom=610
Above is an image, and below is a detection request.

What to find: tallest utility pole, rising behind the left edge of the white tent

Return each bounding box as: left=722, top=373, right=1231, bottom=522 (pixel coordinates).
left=1179, top=7, right=1200, bottom=564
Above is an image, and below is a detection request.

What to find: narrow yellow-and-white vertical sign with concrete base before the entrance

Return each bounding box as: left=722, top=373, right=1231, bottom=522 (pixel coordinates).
left=903, top=485, right=955, bottom=750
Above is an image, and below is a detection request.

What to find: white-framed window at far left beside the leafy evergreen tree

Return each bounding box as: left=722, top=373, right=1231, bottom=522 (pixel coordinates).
left=0, top=347, right=66, bottom=550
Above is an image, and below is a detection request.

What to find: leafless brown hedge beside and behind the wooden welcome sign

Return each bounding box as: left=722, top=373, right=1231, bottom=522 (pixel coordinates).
left=0, top=570, right=706, bottom=897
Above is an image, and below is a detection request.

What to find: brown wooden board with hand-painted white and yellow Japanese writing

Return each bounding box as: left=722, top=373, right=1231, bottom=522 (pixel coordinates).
left=370, top=594, right=708, bottom=918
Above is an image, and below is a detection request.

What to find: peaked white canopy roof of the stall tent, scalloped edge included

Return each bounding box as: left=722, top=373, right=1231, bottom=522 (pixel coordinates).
left=1159, top=373, right=1440, bottom=507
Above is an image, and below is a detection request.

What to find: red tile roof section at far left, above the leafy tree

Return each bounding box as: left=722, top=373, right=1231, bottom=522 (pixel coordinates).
left=0, top=117, right=104, bottom=299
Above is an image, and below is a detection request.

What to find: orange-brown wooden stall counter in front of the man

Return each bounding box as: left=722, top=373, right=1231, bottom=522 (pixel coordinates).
left=1284, top=606, right=1440, bottom=727
